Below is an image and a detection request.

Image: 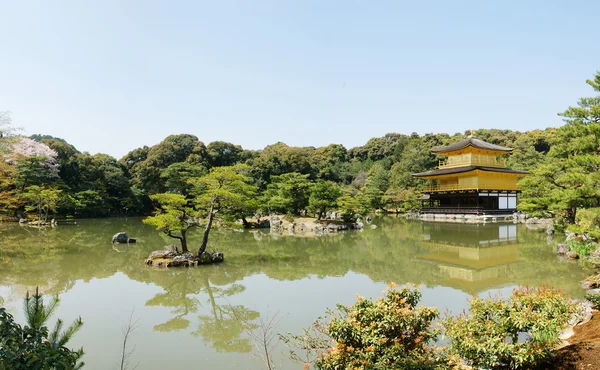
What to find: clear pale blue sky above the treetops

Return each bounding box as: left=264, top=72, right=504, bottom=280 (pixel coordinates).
left=0, top=0, right=600, bottom=157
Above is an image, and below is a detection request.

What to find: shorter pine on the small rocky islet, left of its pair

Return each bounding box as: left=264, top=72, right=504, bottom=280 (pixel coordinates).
left=143, top=193, right=198, bottom=253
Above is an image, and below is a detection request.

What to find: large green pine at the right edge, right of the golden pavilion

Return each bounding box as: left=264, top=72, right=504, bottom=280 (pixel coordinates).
left=519, top=72, right=600, bottom=223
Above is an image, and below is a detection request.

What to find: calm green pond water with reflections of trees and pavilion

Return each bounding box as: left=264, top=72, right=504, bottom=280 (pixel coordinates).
left=0, top=217, right=586, bottom=369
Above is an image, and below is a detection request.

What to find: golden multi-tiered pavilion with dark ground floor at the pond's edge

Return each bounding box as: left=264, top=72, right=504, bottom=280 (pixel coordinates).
left=412, top=137, right=529, bottom=215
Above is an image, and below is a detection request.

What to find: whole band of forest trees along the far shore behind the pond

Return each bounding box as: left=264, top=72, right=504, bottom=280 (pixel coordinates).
left=0, top=73, right=600, bottom=234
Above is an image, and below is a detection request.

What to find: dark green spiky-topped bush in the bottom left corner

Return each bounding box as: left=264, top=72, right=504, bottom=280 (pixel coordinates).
left=0, top=289, right=83, bottom=370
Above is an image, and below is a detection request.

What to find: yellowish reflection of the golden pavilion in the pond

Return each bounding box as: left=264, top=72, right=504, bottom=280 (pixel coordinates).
left=417, top=223, right=521, bottom=294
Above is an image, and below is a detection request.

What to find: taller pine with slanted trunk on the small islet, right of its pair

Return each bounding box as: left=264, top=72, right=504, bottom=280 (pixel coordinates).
left=193, top=165, right=257, bottom=256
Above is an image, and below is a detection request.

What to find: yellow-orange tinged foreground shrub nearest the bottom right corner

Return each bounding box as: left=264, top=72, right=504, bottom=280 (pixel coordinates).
left=445, top=288, right=577, bottom=369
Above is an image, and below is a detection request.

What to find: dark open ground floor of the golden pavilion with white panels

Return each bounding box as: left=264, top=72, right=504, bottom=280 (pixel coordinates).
left=421, top=191, right=517, bottom=215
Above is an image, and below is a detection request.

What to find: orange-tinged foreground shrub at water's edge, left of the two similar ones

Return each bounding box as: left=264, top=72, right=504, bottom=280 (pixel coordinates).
left=316, top=284, right=442, bottom=370
